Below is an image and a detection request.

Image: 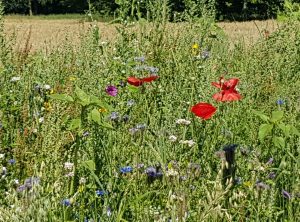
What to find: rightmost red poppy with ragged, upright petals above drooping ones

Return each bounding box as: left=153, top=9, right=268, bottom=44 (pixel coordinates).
left=212, top=77, right=242, bottom=102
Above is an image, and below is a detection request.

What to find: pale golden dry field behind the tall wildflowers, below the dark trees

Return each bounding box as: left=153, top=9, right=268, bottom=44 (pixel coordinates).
left=5, top=16, right=278, bottom=51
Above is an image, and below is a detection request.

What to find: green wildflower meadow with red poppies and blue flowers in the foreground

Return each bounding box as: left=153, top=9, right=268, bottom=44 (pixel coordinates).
left=0, top=1, right=300, bottom=222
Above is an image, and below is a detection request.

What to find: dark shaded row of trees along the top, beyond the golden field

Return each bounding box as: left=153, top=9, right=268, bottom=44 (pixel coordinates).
left=0, top=0, right=300, bottom=20
